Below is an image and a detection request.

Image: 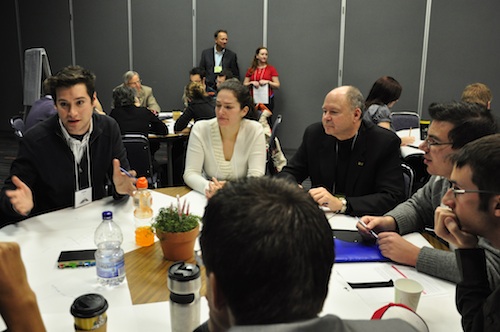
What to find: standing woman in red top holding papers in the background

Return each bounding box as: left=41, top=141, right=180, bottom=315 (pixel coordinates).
left=243, top=46, right=280, bottom=126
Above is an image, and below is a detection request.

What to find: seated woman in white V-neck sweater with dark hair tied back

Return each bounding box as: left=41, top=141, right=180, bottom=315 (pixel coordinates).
left=184, top=79, right=266, bottom=198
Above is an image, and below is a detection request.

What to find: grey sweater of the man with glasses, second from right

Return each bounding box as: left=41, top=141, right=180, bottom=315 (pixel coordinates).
left=385, top=176, right=500, bottom=289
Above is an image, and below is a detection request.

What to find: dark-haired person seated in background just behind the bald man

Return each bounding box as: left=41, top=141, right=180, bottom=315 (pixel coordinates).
left=363, top=76, right=415, bottom=145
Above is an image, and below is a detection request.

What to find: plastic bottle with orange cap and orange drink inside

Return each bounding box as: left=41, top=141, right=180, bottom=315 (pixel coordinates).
left=134, top=177, right=155, bottom=247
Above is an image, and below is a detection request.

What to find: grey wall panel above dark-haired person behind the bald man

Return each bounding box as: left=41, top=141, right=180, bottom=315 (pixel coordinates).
left=342, top=0, right=426, bottom=111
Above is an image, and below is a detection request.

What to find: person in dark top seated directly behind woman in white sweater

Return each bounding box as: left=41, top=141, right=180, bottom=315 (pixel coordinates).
left=174, top=82, right=215, bottom=131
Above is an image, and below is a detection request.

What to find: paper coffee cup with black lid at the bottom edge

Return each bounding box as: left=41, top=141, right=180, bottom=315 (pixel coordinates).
left=71, top=293, right=108, bottom=332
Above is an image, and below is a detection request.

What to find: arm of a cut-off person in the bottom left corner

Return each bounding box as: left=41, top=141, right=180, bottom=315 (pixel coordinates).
left=0, top=242, right=45, bottom=332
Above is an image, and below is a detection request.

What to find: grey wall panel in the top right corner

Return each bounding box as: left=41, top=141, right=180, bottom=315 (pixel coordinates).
left=424, top=0, right=500, bottom=115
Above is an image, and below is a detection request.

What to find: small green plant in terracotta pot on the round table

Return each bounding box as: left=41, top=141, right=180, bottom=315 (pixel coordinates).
left=152, top=200, right=201, bottom=261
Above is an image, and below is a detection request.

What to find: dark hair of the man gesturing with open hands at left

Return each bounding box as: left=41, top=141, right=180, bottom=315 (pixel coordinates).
left=47, top=66, right=95, bottom=102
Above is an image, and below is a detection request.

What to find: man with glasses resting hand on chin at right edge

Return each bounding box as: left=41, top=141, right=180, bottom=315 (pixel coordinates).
left=435, top=134, right=500, bottom=332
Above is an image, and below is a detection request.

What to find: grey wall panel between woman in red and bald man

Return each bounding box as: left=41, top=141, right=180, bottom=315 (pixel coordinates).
left=268, top=0, right=340, bottom=149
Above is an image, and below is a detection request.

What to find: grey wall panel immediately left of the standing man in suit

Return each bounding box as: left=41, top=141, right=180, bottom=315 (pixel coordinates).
left=132, top=0, right=193, bottom=111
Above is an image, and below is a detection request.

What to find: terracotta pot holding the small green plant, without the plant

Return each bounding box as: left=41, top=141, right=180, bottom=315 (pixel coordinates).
left=156, top=225, right=200, bottom=262
